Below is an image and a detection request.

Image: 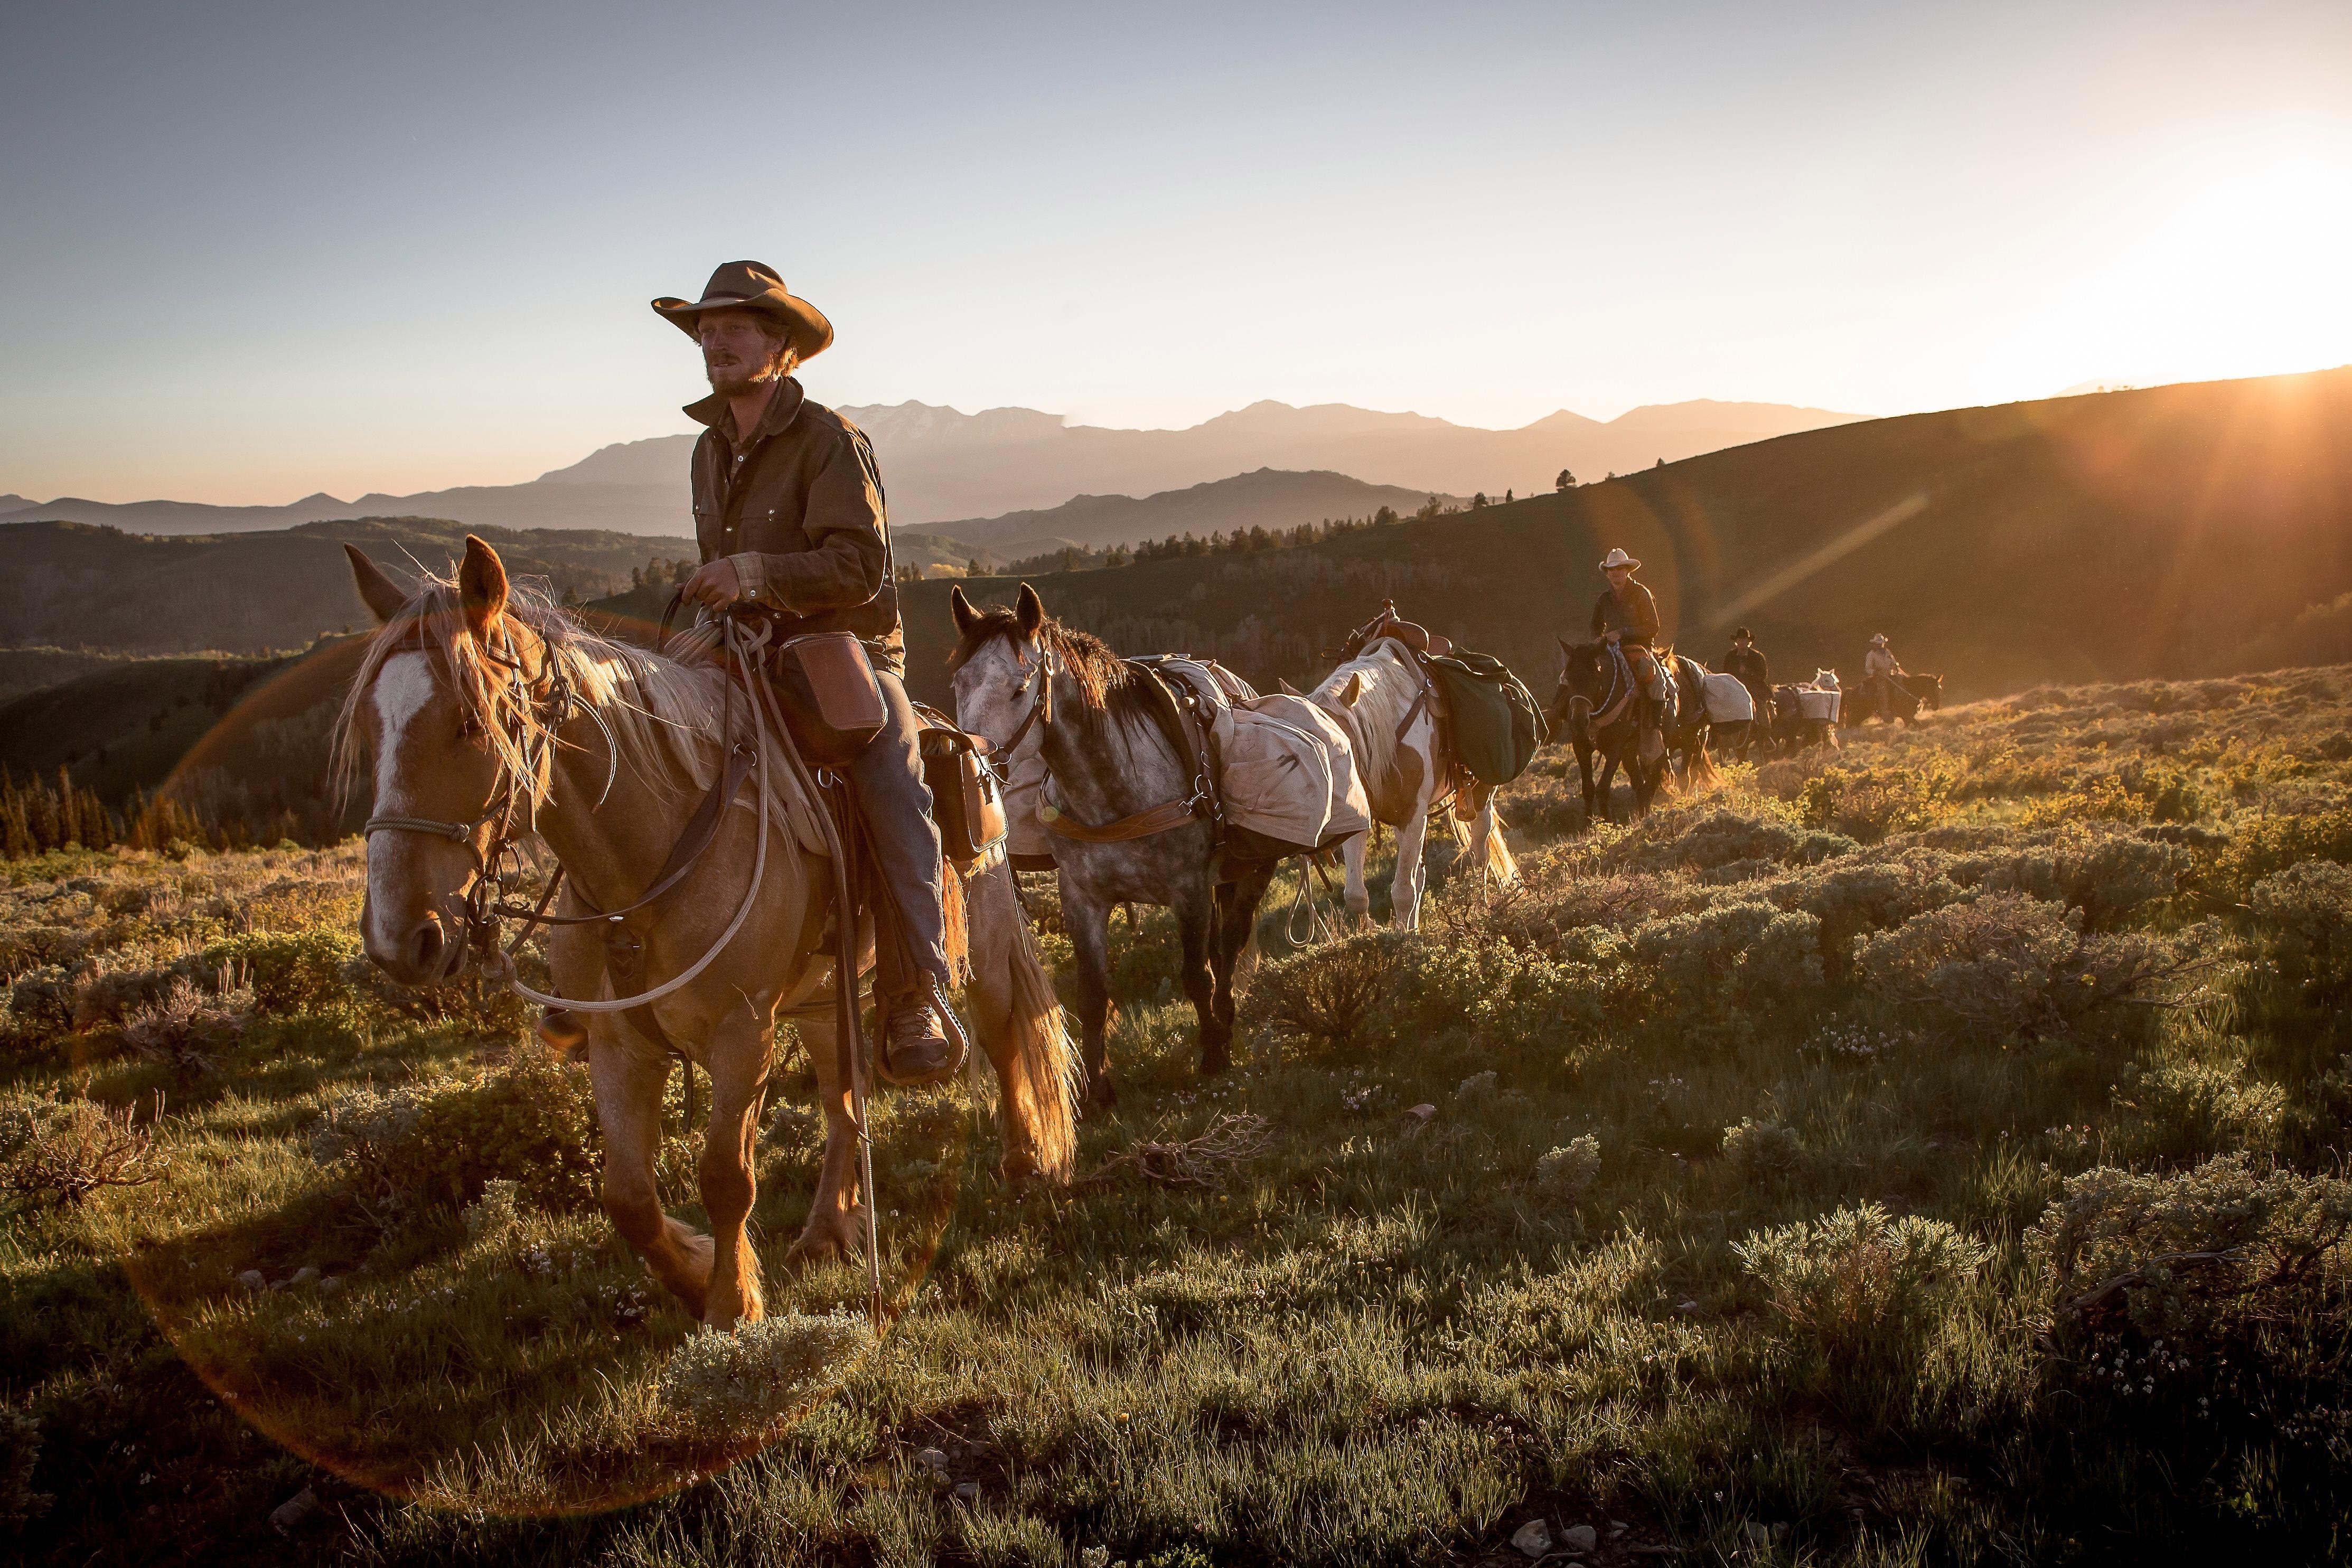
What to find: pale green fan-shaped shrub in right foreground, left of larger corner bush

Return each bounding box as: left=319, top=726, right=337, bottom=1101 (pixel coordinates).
left=1731, top=1204, right=1992, bottom=1364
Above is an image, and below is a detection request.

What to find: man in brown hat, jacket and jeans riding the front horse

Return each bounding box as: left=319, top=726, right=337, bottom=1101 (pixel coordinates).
left=544, top=261, right=957, bottom=1084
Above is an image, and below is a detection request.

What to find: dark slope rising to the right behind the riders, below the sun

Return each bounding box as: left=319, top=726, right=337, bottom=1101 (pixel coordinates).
left=905, top=369, right=2352, bottom=700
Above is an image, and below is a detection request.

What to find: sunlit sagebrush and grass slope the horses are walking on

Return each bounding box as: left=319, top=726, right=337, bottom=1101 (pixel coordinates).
left=0, top=668, right=2352, bottom=1568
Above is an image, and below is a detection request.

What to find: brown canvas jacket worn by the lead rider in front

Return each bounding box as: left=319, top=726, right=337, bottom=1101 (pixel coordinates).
left=687, top=376, right=905, bottom=675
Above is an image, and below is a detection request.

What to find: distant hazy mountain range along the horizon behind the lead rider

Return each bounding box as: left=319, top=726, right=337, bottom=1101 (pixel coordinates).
left=0, top=400, right=1858, bottom=536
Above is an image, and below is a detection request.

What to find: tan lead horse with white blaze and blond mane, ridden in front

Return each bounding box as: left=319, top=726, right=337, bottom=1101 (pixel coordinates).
left=339, top=538, right=1073, bottom=1328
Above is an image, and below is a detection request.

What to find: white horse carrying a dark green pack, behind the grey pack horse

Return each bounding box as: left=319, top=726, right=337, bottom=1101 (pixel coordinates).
left=1308, top=625, right=1520, bottom=931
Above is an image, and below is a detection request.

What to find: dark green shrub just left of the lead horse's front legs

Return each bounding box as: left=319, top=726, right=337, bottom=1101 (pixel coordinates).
left=311, top=1051, right=597, bottom=1223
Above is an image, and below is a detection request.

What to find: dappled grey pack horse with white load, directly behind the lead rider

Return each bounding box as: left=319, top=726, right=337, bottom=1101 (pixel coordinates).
left=948, top=583, right=1275, bottom=1107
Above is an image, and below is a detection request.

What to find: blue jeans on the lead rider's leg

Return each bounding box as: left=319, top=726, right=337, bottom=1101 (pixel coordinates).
left=849, top=670, right=948, bottom=997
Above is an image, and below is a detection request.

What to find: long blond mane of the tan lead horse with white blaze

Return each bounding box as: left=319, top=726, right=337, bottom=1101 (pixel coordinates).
left=334, top=571, right=727, bottom=822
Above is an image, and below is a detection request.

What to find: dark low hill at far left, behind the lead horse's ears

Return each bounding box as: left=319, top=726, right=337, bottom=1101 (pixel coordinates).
left=0, top=517, right=694, bottom=653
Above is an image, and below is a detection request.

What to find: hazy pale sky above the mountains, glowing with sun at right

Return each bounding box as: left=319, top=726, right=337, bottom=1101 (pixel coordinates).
left=0, top=0, right=2352, bottom=503
